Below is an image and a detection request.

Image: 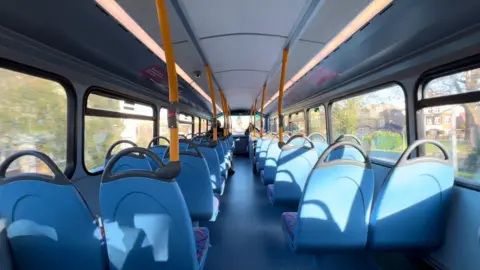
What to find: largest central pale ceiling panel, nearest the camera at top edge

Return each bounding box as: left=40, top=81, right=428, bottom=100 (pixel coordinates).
left=181, top=0, right=310, bottom=38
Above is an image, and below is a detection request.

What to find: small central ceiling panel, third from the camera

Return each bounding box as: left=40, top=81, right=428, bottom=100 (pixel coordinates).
left=215, top=71, right=268, bottom=91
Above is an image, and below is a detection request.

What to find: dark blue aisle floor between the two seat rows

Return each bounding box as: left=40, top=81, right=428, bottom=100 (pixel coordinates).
left=202, top=157, right=316, bottom=270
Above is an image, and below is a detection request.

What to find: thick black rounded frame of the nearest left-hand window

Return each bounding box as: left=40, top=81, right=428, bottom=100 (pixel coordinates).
left=0, top=58, right=77, bottom=179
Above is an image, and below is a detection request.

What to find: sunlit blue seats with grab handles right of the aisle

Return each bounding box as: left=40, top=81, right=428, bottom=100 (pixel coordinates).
left=251, top=135, right=454, bottom=268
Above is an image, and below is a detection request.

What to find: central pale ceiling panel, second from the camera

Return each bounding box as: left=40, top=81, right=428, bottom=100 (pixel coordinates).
left=201, top=35, right=285, bottom=73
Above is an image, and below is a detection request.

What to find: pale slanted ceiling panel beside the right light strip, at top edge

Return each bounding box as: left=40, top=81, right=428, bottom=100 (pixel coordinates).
left=301, top=0, right=371, bottom=42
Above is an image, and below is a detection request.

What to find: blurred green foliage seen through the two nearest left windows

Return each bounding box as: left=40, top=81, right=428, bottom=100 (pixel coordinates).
left=0, top=69, right=125, bottom=169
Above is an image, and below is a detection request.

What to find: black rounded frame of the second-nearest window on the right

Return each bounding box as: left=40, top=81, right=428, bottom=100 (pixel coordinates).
left=325, top=81, right=411, bottom=168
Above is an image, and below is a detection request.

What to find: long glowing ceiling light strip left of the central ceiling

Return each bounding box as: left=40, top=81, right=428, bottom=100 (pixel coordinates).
left=95, top=0, right=220, bottom=110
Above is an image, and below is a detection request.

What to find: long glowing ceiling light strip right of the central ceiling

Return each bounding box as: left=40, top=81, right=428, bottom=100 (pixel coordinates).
left=265, top=0, right=393, bottom=108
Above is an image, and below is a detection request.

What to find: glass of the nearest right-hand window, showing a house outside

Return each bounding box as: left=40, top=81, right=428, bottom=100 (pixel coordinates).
left=417, top=69, right=480, bottom=183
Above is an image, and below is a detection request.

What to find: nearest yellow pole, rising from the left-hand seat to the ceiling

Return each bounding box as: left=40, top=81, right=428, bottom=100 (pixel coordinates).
left=156, top=0, right=179, bottom=162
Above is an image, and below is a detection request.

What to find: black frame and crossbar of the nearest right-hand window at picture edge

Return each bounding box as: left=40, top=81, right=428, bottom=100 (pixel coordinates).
left=414, top=55, right=480, bottom=191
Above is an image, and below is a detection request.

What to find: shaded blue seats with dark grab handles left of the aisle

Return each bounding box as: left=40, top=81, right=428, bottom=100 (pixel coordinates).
left=0, top=135, right=233, bottom=270
